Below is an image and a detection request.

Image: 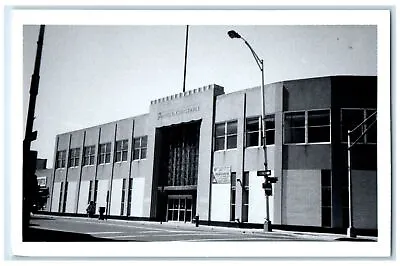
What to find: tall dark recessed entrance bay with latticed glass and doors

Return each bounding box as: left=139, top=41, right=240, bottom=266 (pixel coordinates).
left=155, top=121, right=201, bottom=222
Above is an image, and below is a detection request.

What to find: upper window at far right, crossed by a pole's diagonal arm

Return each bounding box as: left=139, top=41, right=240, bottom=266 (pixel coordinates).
left=341, top=109, right=377, bottom=144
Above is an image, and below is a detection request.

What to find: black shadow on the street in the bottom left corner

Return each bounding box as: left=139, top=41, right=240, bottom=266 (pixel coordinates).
left=22, top=228, right=123, bottom=242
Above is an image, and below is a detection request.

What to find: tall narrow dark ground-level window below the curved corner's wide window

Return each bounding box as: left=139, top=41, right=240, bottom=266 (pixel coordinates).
left=321, top=170, right=332, bottom=227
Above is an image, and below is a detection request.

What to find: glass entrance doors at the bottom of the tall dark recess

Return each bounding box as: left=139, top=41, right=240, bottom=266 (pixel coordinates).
left=167, top=196, right=193, bottom=222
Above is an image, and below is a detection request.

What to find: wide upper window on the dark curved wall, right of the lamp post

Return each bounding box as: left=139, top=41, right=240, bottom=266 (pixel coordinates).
left=284, top=110, right=331, bottom=144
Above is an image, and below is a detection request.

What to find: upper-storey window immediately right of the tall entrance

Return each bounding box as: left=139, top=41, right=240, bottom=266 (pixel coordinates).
left=215, top=121, right=237, bottom=151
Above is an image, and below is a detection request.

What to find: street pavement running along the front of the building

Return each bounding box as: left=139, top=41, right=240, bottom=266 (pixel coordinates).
left=24, top=214, right=376, bottom=242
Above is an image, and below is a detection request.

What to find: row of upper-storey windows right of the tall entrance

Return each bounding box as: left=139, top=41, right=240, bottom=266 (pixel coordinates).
left=214, top=109, right=377, bottom=151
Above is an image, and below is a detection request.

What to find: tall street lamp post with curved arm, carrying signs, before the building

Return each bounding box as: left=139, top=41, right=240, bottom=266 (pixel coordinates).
left=228, top=30, right=272, bottom=232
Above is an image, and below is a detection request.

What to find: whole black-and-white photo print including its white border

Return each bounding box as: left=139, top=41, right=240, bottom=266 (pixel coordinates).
left=4, top=6, right=391, bottom=257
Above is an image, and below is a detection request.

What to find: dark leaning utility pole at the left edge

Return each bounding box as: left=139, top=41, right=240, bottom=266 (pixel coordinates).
left=22, top=25, right=45, bottom=233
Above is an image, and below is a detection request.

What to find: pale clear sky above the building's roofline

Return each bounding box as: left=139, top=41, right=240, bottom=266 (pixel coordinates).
left=23, top=25, right=377, bottom=168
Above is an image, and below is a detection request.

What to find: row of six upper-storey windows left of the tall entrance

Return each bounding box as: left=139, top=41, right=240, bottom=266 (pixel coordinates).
left=56, top=136, right=147, bottom=168
